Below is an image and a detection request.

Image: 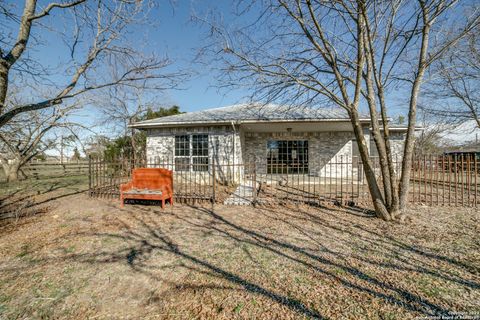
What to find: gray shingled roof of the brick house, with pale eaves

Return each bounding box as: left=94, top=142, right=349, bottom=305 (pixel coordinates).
left=132, top=104, right=368, bottom=128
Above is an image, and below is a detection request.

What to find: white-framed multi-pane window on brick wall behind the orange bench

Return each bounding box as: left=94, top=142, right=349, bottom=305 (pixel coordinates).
left=175, top=134, right=208, bottom=171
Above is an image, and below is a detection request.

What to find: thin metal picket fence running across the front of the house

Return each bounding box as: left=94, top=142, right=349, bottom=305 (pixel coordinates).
left=88, top=156, right=480, bottom=207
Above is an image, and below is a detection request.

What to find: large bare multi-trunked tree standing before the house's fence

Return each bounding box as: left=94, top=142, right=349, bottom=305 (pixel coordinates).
left=202, top=0, right=479, bottom=220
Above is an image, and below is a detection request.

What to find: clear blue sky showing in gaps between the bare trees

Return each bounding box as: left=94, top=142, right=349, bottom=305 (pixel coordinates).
left=4, top=0, right=416, bottom=127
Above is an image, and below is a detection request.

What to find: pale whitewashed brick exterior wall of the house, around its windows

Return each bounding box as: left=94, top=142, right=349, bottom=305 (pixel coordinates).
left=147, top=126, right=410, bottom=181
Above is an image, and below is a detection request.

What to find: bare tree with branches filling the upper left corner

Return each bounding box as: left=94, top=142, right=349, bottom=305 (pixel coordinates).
left=0, top=0, right=179, bottom=127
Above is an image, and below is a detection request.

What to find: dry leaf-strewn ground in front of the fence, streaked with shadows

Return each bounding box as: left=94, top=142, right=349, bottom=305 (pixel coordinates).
left=0, top=194, right=480, bottom=319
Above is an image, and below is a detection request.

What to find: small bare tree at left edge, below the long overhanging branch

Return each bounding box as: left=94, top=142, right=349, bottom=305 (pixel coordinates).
left=0, top=105, right=81, bottom=182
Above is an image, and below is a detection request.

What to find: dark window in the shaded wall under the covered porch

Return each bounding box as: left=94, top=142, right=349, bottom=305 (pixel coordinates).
left=267, top=140, right=308, bottom=174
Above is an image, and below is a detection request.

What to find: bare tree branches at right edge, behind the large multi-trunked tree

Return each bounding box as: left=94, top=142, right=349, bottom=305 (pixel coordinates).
left=423, top=28, right=480, bottom=129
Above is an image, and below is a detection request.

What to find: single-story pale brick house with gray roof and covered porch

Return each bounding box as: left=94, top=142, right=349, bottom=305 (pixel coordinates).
left=132, top=104, right=406, bottom=181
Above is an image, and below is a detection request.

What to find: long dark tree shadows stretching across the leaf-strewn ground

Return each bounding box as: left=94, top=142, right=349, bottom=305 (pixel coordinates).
left=65, top=206, right=480, bottom=318
